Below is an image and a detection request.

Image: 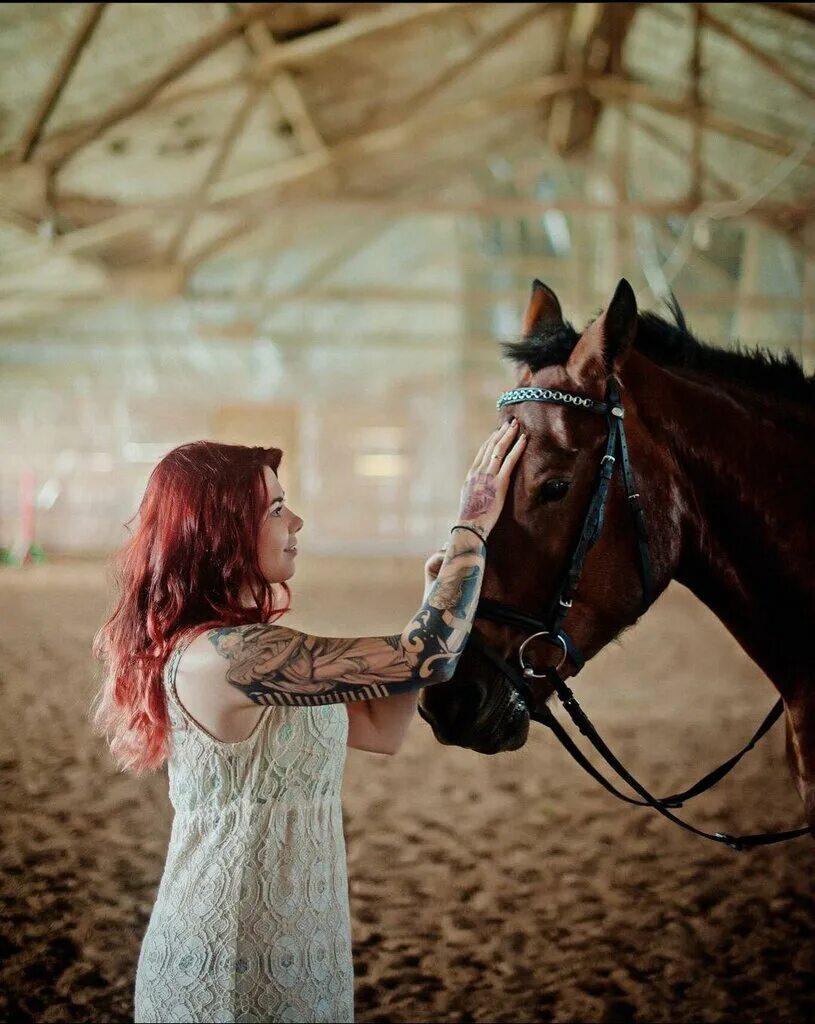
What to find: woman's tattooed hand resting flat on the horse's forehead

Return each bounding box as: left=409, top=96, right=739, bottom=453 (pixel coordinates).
left=457, top=418, right=526, bottom=540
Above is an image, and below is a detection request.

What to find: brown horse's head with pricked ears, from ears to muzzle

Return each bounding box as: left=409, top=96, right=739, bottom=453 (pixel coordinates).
left=420, top=281, right=682, bottom=754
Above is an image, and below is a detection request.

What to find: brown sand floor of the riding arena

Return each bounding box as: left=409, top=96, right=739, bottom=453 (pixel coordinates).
left=0, top=556, right=815, bottom=1022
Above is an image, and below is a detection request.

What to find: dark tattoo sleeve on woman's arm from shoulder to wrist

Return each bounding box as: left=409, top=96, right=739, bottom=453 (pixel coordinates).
left=208, top=530, right=484, bottom=706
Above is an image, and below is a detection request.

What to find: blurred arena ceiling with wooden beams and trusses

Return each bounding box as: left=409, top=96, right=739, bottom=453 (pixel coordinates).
left=0, top=3, right=815, bottom=331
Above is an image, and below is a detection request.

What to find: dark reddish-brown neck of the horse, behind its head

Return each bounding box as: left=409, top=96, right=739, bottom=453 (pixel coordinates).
left=637, top=354, right=815, bottom=693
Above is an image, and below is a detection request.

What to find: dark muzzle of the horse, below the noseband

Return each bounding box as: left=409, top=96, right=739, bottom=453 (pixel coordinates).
left=419, top=674, right=529, bottom=754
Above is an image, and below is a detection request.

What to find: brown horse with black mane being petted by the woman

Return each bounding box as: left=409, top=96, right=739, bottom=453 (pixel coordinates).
left=421, top=281, right=815, bottom=828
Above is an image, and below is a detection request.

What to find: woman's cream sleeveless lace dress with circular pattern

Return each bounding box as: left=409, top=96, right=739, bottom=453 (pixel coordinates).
left=135, top=643, right=353, bottom=1024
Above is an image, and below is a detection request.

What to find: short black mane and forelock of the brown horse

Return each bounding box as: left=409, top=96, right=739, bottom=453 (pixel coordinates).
left=502, top=298, right=815, bottom=406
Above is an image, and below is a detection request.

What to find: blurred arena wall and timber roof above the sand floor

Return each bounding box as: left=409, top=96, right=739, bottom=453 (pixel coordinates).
left=0, top=3, right=815, bottom=557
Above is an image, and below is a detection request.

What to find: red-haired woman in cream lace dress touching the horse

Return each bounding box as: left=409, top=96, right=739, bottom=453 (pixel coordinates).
left=96, top=423, right=525, bottom=1024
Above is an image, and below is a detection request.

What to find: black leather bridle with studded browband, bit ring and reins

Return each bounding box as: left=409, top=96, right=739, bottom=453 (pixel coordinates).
left=470, top=380, right=811, bottom=850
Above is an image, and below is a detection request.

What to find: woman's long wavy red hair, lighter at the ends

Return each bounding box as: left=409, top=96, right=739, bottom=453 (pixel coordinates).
left=93, top=441, right=289, bottom=772
